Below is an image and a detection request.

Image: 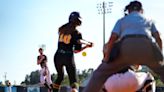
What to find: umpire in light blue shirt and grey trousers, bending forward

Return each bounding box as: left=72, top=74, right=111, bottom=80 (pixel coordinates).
left=83, top=1, right=164, bottom=92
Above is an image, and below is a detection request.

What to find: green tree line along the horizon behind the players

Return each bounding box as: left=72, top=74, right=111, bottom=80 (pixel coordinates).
left=21, top=67, right=164, bottom=86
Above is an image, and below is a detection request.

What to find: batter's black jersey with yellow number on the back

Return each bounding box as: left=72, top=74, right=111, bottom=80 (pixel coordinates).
left=58, top=25, right=82, bottom=51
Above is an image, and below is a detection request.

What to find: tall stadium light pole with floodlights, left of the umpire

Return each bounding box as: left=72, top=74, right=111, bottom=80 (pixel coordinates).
left=97, top=1, right=113, bottom=45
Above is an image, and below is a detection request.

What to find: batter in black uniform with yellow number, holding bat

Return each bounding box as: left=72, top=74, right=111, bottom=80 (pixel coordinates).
left=53, top=11, right=92, bottom=92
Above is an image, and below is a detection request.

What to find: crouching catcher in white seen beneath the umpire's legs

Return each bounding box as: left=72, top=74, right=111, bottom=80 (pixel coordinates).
left=101, top=65, right=156, bottom=92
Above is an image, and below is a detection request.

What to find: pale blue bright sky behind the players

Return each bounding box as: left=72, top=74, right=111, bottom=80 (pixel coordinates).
left=0, top=0, right=164, bottom=84
